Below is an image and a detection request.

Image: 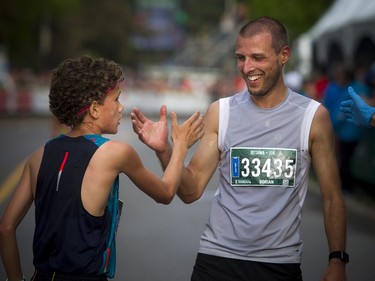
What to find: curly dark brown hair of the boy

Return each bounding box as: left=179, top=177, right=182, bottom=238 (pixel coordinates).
left=49, top=56, right=123, bottom=127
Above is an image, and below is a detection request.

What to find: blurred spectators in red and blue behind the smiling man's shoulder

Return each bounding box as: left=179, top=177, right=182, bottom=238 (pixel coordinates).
left=285, top=64, right=375, bottom=193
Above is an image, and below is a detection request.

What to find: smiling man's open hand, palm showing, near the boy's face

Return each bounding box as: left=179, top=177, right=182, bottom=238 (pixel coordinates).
left=130, top=105, right=169, bottom=152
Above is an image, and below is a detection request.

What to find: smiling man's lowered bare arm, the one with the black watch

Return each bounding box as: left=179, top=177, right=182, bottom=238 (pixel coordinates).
left=310, top=106, right=346, bottom=281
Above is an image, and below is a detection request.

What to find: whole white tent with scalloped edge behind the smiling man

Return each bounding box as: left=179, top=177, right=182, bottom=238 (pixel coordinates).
left=295, top=0, right=375, bottom=76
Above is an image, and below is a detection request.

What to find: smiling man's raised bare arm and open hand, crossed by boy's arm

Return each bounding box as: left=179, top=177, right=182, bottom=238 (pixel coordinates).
left=132, top=102, right=220, bottom=203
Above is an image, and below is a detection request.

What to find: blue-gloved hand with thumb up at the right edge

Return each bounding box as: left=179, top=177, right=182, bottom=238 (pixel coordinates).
left=340, top=87, right=375, bottom=127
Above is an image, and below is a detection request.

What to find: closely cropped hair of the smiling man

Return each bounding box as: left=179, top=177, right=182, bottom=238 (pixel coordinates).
left=239, top=17, right=289, bottom=53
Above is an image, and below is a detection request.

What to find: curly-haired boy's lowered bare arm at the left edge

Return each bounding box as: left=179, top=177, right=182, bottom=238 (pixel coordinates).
left=0, top=162, right=33, bottom=281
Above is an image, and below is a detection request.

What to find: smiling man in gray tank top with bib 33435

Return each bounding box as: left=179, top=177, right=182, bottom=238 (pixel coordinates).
left=132, top=17, right=349, bottom=281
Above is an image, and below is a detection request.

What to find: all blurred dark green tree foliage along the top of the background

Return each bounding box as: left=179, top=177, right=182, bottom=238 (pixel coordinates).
left=0, top=0, right=332, bottom=70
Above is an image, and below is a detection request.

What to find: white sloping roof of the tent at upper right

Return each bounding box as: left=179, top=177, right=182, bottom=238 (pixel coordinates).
left=309, top=0, right=375, bottom=39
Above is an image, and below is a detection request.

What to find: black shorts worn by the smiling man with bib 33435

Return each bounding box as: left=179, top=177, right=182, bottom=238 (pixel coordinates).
left=191, top=253, right=302, bottom=281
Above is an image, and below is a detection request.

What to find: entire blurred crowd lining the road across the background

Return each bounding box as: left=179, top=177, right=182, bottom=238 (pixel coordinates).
left=0, top=59, right=375, bottom=193
